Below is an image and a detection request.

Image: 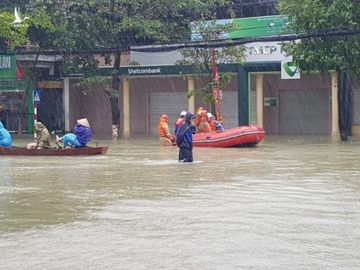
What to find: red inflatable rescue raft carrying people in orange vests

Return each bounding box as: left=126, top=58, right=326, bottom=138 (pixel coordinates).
left=193, top=125, right=265, bottom=147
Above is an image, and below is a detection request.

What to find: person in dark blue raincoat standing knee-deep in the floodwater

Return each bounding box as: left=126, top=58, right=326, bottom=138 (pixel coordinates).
left=176, top=112, right=195, bottom=162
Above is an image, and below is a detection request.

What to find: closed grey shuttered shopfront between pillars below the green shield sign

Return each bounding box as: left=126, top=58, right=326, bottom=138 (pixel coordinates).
left=258, top=74, right=331, bottom=134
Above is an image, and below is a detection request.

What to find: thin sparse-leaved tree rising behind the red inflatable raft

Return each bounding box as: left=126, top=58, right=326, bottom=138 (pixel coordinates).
left=178, top=20, right=245, bottom=116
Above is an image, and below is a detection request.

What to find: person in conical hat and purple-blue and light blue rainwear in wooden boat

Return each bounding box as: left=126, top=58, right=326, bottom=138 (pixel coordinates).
left=56, top=118, right=92, bottom=148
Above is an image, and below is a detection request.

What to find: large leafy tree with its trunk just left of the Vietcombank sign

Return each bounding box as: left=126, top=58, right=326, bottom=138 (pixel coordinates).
left=29, top=0, right=225, bottom=131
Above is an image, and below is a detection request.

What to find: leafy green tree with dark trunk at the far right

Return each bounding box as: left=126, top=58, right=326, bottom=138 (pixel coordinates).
left=279, top=0, right=360, bottom=140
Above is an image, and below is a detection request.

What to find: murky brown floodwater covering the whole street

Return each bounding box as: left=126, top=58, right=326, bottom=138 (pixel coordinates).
left=0, top=137, right=360, bottom=270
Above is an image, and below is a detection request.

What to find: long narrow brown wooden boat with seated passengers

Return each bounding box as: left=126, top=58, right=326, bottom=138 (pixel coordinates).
left=0, top=146, right=108, bottom=156
